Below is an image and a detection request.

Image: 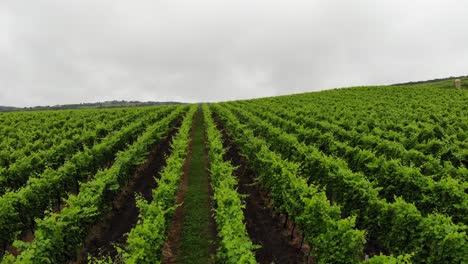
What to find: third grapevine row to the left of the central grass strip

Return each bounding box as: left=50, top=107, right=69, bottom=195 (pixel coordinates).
left=0, top=107, right=184, bottom=248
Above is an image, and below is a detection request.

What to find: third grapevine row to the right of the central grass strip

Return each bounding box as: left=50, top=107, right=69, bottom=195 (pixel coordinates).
left=218, top=104, right=468, bottom=263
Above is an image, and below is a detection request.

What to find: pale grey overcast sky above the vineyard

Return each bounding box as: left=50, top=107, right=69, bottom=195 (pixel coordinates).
left=0, top=0, right=468, bottom=106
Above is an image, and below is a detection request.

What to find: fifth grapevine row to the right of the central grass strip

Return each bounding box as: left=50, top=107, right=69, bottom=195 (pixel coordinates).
left=256, top=99, right=468, bottom=181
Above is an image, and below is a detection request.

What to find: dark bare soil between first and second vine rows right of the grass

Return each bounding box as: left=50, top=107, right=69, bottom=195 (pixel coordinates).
left=214, top=115, right=313, bottom=264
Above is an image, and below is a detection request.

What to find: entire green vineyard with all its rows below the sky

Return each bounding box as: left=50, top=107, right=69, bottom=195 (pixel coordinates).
left=0, top=81, right=468, bottom=264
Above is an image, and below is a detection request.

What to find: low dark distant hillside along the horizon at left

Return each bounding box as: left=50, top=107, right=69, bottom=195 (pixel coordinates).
left=0, top=101, right=182, bottom=112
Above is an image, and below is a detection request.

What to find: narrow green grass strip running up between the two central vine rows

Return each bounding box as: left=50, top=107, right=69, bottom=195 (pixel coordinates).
left=177, top=106, right=216, bottom=263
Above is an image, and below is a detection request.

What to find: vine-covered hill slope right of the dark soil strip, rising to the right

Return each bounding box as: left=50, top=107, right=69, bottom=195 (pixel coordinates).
left=213, top=80, right=468, bottom=263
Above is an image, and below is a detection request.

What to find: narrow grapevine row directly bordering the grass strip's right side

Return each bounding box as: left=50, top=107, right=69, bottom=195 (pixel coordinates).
left=203, top=105, right=256, bottom=263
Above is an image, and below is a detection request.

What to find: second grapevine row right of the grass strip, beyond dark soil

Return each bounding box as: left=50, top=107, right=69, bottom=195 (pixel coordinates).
left=213, top=105, right=408, bottom=263
